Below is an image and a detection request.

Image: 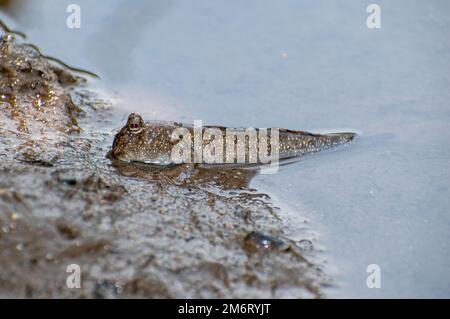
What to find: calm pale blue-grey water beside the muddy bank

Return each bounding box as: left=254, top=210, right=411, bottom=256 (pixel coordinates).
left=1, top=0, right=450, bottom=298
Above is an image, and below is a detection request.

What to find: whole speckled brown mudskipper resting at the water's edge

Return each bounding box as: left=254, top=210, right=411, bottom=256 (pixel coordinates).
left=112, top=113, right=356, bottom=165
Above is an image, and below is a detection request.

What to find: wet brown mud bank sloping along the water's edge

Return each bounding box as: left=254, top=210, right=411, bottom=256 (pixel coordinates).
left=0, top=28, right=327, bottom=298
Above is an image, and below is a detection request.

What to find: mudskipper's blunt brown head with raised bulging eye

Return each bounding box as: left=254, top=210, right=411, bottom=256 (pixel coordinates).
left=112, top=113, right=145, bottom=162
